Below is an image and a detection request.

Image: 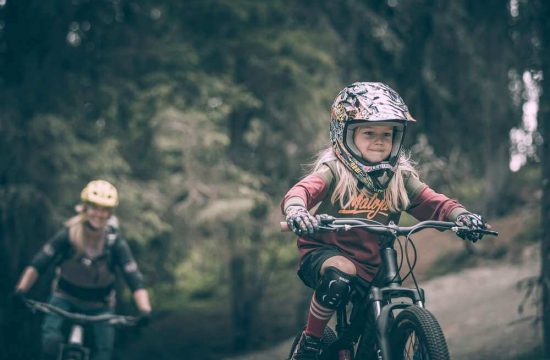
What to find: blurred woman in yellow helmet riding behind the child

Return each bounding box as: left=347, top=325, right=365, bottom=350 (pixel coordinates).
left=15, top=180, right=151, bottom=360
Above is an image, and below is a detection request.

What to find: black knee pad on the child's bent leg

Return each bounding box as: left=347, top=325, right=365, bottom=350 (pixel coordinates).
left=315, top=266, right=355, bottom=309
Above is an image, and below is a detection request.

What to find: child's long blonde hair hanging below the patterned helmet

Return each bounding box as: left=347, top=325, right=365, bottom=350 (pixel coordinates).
left=311, top=146, right=418, bottom=212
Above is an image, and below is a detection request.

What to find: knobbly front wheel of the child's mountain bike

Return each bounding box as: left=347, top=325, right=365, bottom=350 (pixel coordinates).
left=390, top=306, right=450, bottom=360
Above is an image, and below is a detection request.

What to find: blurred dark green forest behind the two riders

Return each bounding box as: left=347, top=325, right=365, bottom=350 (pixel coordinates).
left=0, top=0, right=550, bottom=360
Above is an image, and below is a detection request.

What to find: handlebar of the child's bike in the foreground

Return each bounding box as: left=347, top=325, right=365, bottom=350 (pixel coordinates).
left=280, top=218, right=498, bottom=236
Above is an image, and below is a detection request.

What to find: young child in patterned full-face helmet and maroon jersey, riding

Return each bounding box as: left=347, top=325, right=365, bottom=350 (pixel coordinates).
left=281, top=82, right=487, bottom=360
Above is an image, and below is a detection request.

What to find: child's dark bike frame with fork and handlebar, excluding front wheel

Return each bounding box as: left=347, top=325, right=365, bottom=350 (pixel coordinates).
left=298, top=219, right=498, bottom=360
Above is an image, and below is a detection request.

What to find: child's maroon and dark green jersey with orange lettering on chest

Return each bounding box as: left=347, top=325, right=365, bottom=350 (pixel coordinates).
left=281, top=164, right=467, bottom=282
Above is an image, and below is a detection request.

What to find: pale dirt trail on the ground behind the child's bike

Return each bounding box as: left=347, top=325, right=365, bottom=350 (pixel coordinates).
left=225, top=246, right=541, bottom=360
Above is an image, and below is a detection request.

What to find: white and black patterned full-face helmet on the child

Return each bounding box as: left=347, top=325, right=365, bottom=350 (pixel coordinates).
left=330, top=82, right=416, bottom=192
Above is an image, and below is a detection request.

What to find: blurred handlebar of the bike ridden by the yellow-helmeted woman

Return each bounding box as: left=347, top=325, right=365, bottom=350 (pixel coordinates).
left=23, top=298, right=138, bottom=327
